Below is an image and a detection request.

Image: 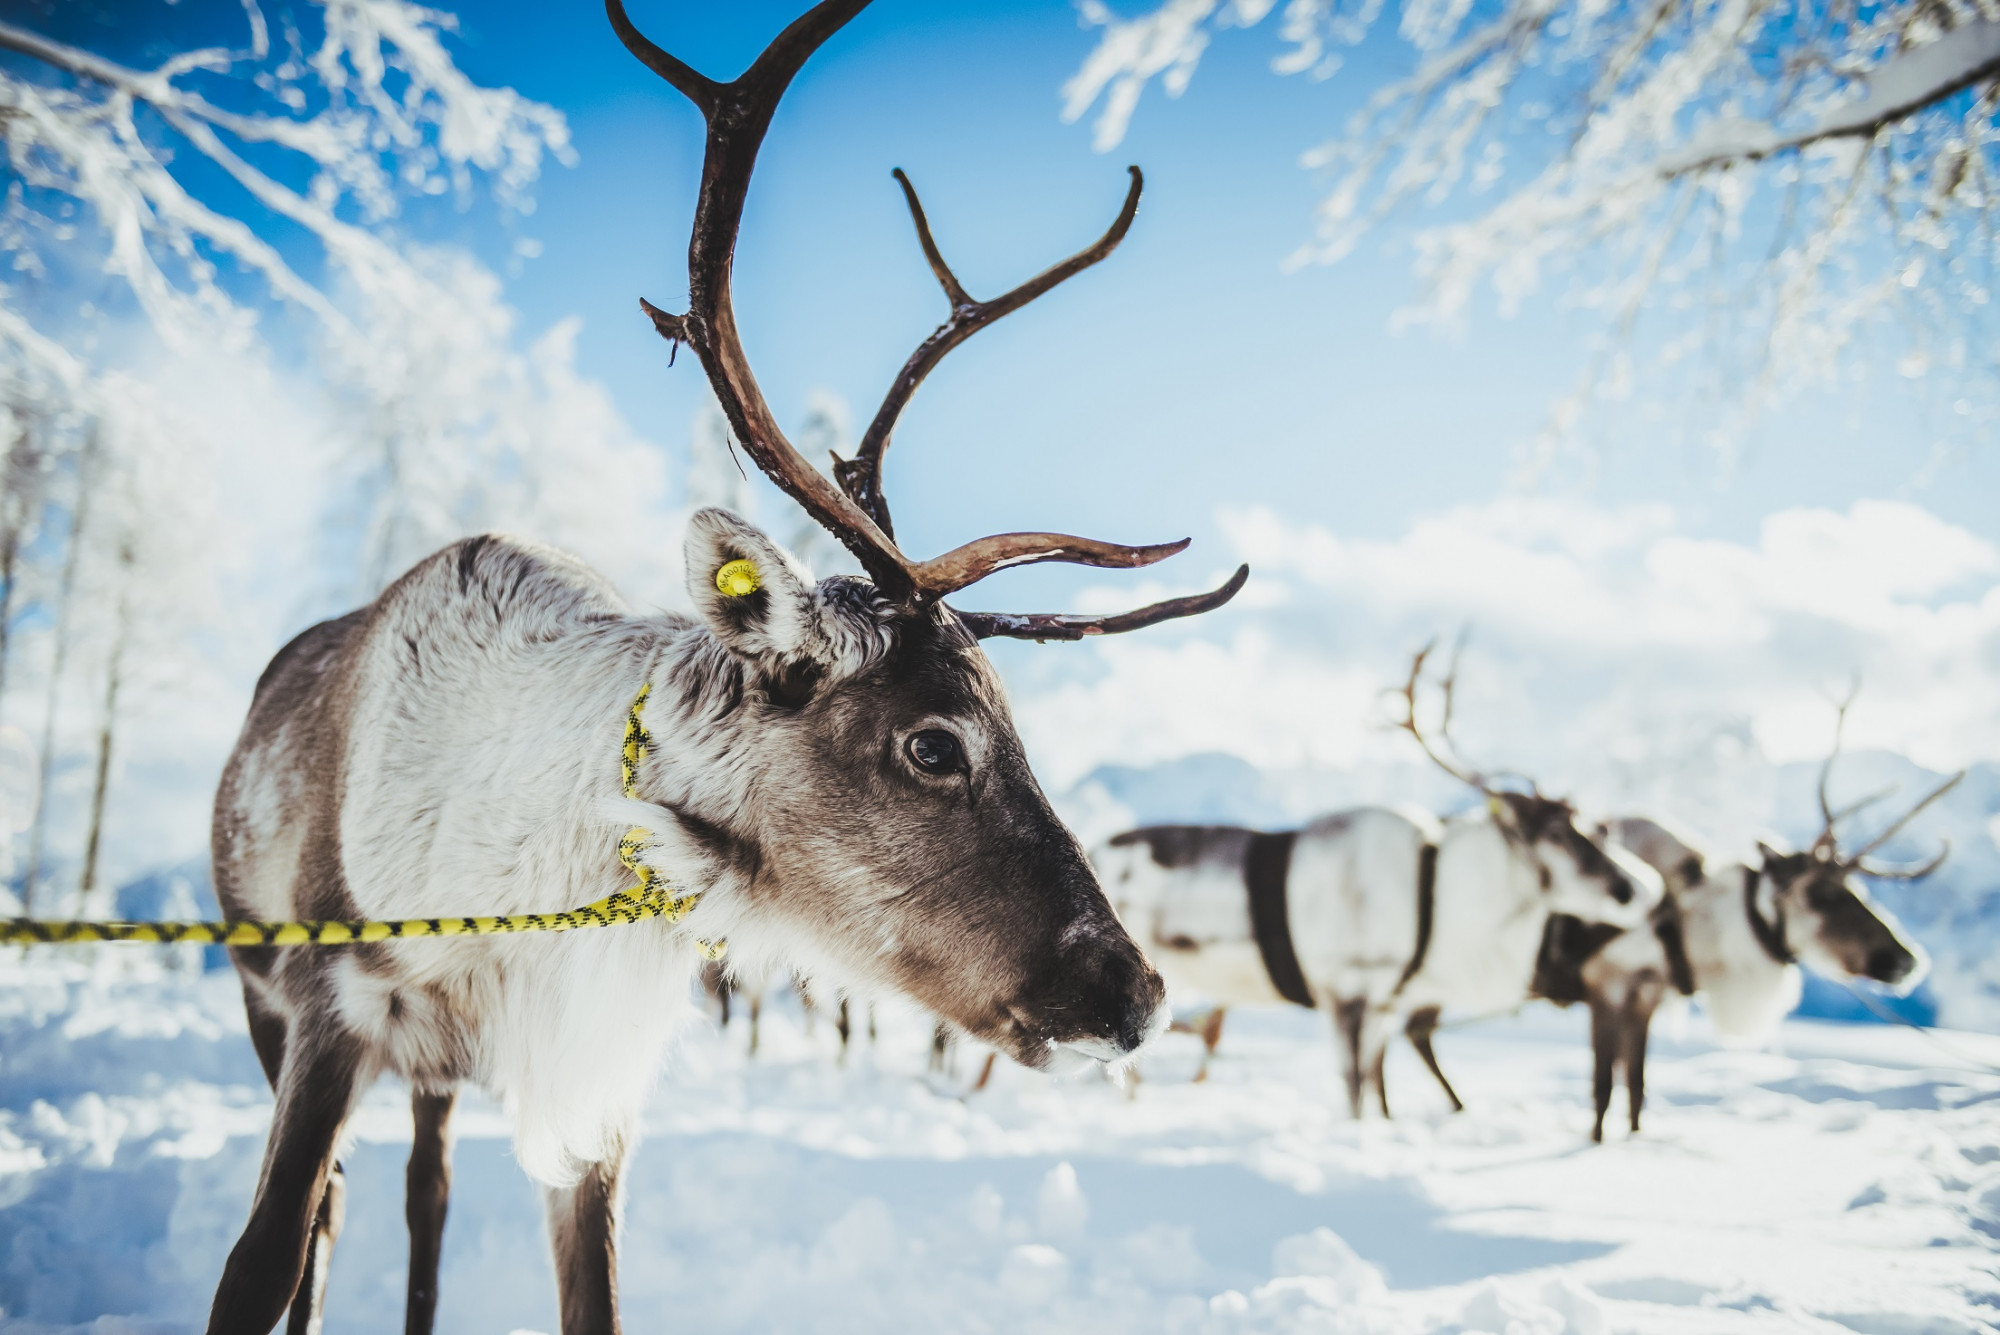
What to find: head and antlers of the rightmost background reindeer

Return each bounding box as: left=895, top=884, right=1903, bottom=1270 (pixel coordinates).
left=1744, top=683, right=1966, bottom=989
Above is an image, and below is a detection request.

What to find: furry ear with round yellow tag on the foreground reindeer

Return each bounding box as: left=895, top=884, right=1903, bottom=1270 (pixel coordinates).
left=686, top=508, right=824, bottom=671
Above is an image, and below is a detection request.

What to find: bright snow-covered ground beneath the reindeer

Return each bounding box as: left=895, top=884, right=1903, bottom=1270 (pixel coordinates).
left=0, top=947, right=2000, bottom=1335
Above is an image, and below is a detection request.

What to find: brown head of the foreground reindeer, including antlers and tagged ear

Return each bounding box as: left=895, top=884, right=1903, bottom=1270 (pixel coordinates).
left=606, top=0, right=1248, bottom=1065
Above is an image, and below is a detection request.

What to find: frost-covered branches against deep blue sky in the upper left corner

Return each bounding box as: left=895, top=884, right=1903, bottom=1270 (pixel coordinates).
left=0, top=0, right=570, bottom=351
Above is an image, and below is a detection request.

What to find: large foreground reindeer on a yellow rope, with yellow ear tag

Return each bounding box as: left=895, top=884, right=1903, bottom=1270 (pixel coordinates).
left=208, top=0, right=1248, bottom=1335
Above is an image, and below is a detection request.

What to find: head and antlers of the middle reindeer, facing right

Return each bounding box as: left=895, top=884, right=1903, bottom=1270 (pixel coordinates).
left=1394, top=644, right=1664, bottom=927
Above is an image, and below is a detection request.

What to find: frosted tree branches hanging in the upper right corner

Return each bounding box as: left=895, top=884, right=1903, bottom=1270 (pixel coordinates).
left=1066, top=0, right=2000, bottom=455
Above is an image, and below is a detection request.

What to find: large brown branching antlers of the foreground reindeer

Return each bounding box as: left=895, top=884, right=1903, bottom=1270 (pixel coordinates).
left=604, top=0, right=1242, bottom=640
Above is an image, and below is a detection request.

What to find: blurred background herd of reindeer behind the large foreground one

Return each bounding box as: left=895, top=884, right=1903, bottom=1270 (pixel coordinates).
left=702, top=648, right=1964, bottom=1141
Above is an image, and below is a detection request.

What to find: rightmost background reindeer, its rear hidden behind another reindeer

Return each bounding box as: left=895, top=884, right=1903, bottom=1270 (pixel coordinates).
left=1538, top=695, right=1964, bottom=1141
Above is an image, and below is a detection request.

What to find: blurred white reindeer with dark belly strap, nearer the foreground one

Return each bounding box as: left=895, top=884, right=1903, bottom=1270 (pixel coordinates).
left=1092, top=650, right=1660, bottom=1117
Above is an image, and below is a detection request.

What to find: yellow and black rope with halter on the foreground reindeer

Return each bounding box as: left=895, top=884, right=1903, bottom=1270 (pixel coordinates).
left=0, top=683, right=728, bottom=959
